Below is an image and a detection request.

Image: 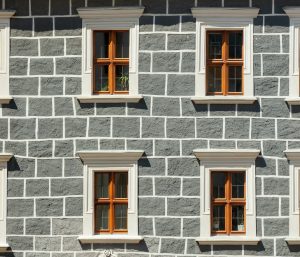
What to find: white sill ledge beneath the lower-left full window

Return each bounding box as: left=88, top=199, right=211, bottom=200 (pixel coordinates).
left=78, top=235, right=144, bottom=244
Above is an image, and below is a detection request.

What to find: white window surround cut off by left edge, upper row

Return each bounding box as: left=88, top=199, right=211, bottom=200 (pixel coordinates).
left=0, top=10, right=16, bottom=104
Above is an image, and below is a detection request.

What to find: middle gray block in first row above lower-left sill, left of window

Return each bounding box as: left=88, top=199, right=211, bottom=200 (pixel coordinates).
left=26, top=218, right=50, bottom=235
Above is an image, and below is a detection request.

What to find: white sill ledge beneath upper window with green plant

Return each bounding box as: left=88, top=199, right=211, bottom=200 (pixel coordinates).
left=77, top=95, right=143, bottom=103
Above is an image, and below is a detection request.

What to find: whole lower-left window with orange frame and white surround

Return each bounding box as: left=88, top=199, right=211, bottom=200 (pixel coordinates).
left=78, top=151, right=143, bottom=243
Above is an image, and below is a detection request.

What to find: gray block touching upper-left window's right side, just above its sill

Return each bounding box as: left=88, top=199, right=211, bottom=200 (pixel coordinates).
left=139, top=74, right=166, bottom=95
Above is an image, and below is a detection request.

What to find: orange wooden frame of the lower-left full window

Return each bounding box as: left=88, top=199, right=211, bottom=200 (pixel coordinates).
left=94, top=172, right=128, bottom=234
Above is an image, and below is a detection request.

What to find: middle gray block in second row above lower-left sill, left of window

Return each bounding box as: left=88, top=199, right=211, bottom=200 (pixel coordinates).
left=35, top=198, right=63, bottom=217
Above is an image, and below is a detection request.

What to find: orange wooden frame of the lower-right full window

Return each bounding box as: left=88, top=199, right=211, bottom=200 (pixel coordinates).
left=211, top=171, right=246, bottom=235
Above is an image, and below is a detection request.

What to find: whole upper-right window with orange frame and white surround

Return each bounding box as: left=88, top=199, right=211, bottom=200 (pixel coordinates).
left=192, top=7, right=259, bottom=104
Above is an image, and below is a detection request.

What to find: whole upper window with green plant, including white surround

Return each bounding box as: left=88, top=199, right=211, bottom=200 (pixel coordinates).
left=78, top=7, right=144, bottom=103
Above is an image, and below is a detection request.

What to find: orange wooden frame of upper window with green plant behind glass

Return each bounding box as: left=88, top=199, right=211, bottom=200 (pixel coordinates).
left=93, top=30, right=129, bottom=94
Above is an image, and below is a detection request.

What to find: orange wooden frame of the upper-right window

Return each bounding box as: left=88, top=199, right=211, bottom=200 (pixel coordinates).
left=206, top=30, right=244, bottom=95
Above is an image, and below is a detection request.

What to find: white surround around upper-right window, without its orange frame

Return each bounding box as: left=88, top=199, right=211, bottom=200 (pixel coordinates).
left=192, top=7, right=259, bottom=104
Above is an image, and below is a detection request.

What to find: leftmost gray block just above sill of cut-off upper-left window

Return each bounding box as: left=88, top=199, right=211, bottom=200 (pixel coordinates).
left=9, top=78, right=39, bottom=95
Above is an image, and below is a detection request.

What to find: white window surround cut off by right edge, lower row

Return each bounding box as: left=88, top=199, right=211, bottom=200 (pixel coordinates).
left=284, top=149, right=300, bottom=245
